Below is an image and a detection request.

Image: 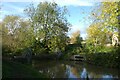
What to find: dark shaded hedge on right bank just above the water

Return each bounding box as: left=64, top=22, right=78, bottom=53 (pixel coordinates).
left=86, top=52, right=120, bottom=68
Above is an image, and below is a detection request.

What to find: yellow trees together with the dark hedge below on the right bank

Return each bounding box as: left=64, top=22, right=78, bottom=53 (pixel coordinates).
left=84, top=2, right=120, bottom=68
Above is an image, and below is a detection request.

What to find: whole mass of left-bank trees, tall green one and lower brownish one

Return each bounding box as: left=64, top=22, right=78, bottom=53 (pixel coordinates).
left=0, top=2, right=70, bottom=55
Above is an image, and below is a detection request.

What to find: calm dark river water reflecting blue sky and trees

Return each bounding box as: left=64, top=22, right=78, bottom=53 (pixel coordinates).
left=32, top=61, right=118, bottom=79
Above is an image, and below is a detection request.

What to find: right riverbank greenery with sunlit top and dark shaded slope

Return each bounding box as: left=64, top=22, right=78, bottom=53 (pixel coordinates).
left=62, top=47, right=120, bottom=69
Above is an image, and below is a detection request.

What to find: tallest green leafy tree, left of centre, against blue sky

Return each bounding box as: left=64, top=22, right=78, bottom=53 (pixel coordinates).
left=25, top=2, right=70, bottom=52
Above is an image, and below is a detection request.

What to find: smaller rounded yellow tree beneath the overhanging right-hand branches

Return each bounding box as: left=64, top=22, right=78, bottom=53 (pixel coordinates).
left=87, top=23, right=111, bottom=45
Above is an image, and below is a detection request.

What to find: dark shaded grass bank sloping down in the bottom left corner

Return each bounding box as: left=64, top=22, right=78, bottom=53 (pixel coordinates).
left=2, top=60, right=45, bottom=79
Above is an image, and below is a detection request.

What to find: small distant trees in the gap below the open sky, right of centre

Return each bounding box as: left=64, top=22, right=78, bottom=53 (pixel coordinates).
left=66, top=30, right=83, bottom=57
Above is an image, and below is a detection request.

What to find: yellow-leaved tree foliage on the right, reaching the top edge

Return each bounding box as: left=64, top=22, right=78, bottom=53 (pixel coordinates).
left=87, top=2, right=120, bottom=52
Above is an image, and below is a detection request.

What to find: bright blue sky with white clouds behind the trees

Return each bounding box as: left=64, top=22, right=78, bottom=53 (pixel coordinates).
left=0, top=0, right=96, bottom=39
